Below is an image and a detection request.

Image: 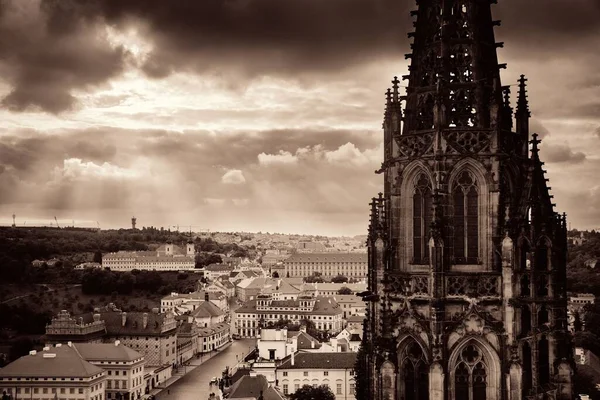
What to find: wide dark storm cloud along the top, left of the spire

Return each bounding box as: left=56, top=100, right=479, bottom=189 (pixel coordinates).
left=95, top=0, right=413, bottom=78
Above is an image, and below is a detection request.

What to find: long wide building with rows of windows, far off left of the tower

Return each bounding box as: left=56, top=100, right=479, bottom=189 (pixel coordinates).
left=283, top=253, right=367, bottom=278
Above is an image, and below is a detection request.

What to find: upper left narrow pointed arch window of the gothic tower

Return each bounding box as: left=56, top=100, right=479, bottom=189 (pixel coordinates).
left=413, top=174, right=432, bottom=264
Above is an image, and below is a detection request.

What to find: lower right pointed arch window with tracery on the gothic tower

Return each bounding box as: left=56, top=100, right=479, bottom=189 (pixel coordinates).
left=454, top=345, right=487, bottom=400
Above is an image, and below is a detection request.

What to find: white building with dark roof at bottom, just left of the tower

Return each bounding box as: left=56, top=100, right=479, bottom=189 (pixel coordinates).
left=276, top=352, right=356, bottom=400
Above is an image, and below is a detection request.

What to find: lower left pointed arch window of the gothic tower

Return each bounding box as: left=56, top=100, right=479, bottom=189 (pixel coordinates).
left=400, top=340, right=429, bottom=400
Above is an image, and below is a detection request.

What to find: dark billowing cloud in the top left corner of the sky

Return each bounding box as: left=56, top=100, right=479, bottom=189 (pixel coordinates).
left=0, top=0, right=125, bottom=113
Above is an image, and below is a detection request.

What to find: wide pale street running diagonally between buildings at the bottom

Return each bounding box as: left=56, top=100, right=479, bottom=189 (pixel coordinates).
left=156, top=339, right=256, bottom=400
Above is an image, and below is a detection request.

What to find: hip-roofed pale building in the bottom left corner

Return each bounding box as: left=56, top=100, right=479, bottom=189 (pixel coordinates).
left=0, top=345, right=107, bottom=400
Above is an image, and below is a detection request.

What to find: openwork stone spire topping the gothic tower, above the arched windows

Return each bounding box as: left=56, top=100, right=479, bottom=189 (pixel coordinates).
left=403, top=0, right=505, bottom=134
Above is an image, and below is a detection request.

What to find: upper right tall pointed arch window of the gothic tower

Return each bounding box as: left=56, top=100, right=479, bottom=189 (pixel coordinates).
left=452, top=171, right=479, bottom=264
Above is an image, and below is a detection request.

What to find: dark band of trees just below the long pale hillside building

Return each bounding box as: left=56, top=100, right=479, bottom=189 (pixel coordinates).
left=81, top=269, right=199, bottom=295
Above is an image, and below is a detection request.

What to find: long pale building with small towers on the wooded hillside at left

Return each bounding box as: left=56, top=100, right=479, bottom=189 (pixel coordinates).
left=102, top=242, right=196, bottom=271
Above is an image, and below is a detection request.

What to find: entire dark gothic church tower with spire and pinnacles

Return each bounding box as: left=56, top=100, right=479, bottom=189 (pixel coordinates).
left=356, top=0, right=574, bottom=400
